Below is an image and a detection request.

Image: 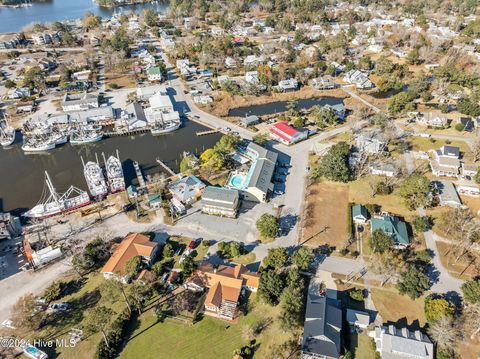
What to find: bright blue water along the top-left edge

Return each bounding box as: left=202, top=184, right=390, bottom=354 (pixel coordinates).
left=0, top=0, right=168, bottom=32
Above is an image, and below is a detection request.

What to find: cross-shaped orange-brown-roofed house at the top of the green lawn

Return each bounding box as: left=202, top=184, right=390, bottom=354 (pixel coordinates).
left=185, top=263, right=260, bottom=320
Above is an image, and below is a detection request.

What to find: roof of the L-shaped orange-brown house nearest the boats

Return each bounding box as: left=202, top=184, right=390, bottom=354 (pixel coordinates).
left=102, top=233, right=157, bottom=276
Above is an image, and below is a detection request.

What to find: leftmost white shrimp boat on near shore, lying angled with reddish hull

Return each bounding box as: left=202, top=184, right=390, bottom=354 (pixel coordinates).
left=23, top=171, right=90, bottom=218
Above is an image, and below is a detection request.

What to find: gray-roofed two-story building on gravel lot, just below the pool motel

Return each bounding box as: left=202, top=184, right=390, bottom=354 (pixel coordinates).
left=201, top=186, right=240, bottom=218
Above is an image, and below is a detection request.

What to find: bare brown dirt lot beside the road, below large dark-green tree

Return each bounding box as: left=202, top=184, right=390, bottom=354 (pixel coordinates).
left=303, top=182, right=348, bottom=249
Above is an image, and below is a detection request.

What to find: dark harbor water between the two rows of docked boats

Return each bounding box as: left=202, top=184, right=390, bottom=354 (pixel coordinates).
left=0, top=121, right=220, bottom=214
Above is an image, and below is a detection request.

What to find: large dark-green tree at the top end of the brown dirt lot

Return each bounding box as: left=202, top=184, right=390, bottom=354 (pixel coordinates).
left=313, top=142, right=351, bottom=182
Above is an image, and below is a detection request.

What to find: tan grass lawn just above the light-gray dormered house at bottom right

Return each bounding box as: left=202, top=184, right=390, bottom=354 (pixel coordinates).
left=372, top=288, right=425, bottom=326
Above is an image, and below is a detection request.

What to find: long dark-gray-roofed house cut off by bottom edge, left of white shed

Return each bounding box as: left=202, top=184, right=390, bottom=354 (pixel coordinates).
left=301, top=282, right=342, bottom=359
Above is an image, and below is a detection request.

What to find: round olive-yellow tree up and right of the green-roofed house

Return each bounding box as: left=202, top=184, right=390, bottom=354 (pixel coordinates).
left=398, top=172, right=430, bottom=210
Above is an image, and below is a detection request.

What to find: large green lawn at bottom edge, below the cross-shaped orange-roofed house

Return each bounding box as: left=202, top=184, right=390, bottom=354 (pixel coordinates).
left=119, top=295, right=291, bottom=359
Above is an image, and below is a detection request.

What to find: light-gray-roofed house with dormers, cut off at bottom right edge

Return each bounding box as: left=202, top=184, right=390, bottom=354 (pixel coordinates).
left=368, top=325, right=434, bottom=359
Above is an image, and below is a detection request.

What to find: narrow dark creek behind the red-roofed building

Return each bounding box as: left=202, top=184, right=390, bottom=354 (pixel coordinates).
left=228, top=97, right=343, bottom=117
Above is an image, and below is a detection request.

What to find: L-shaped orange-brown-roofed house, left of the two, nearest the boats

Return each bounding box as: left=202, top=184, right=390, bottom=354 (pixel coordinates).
left=102, top=233, right=158, bottom=283
